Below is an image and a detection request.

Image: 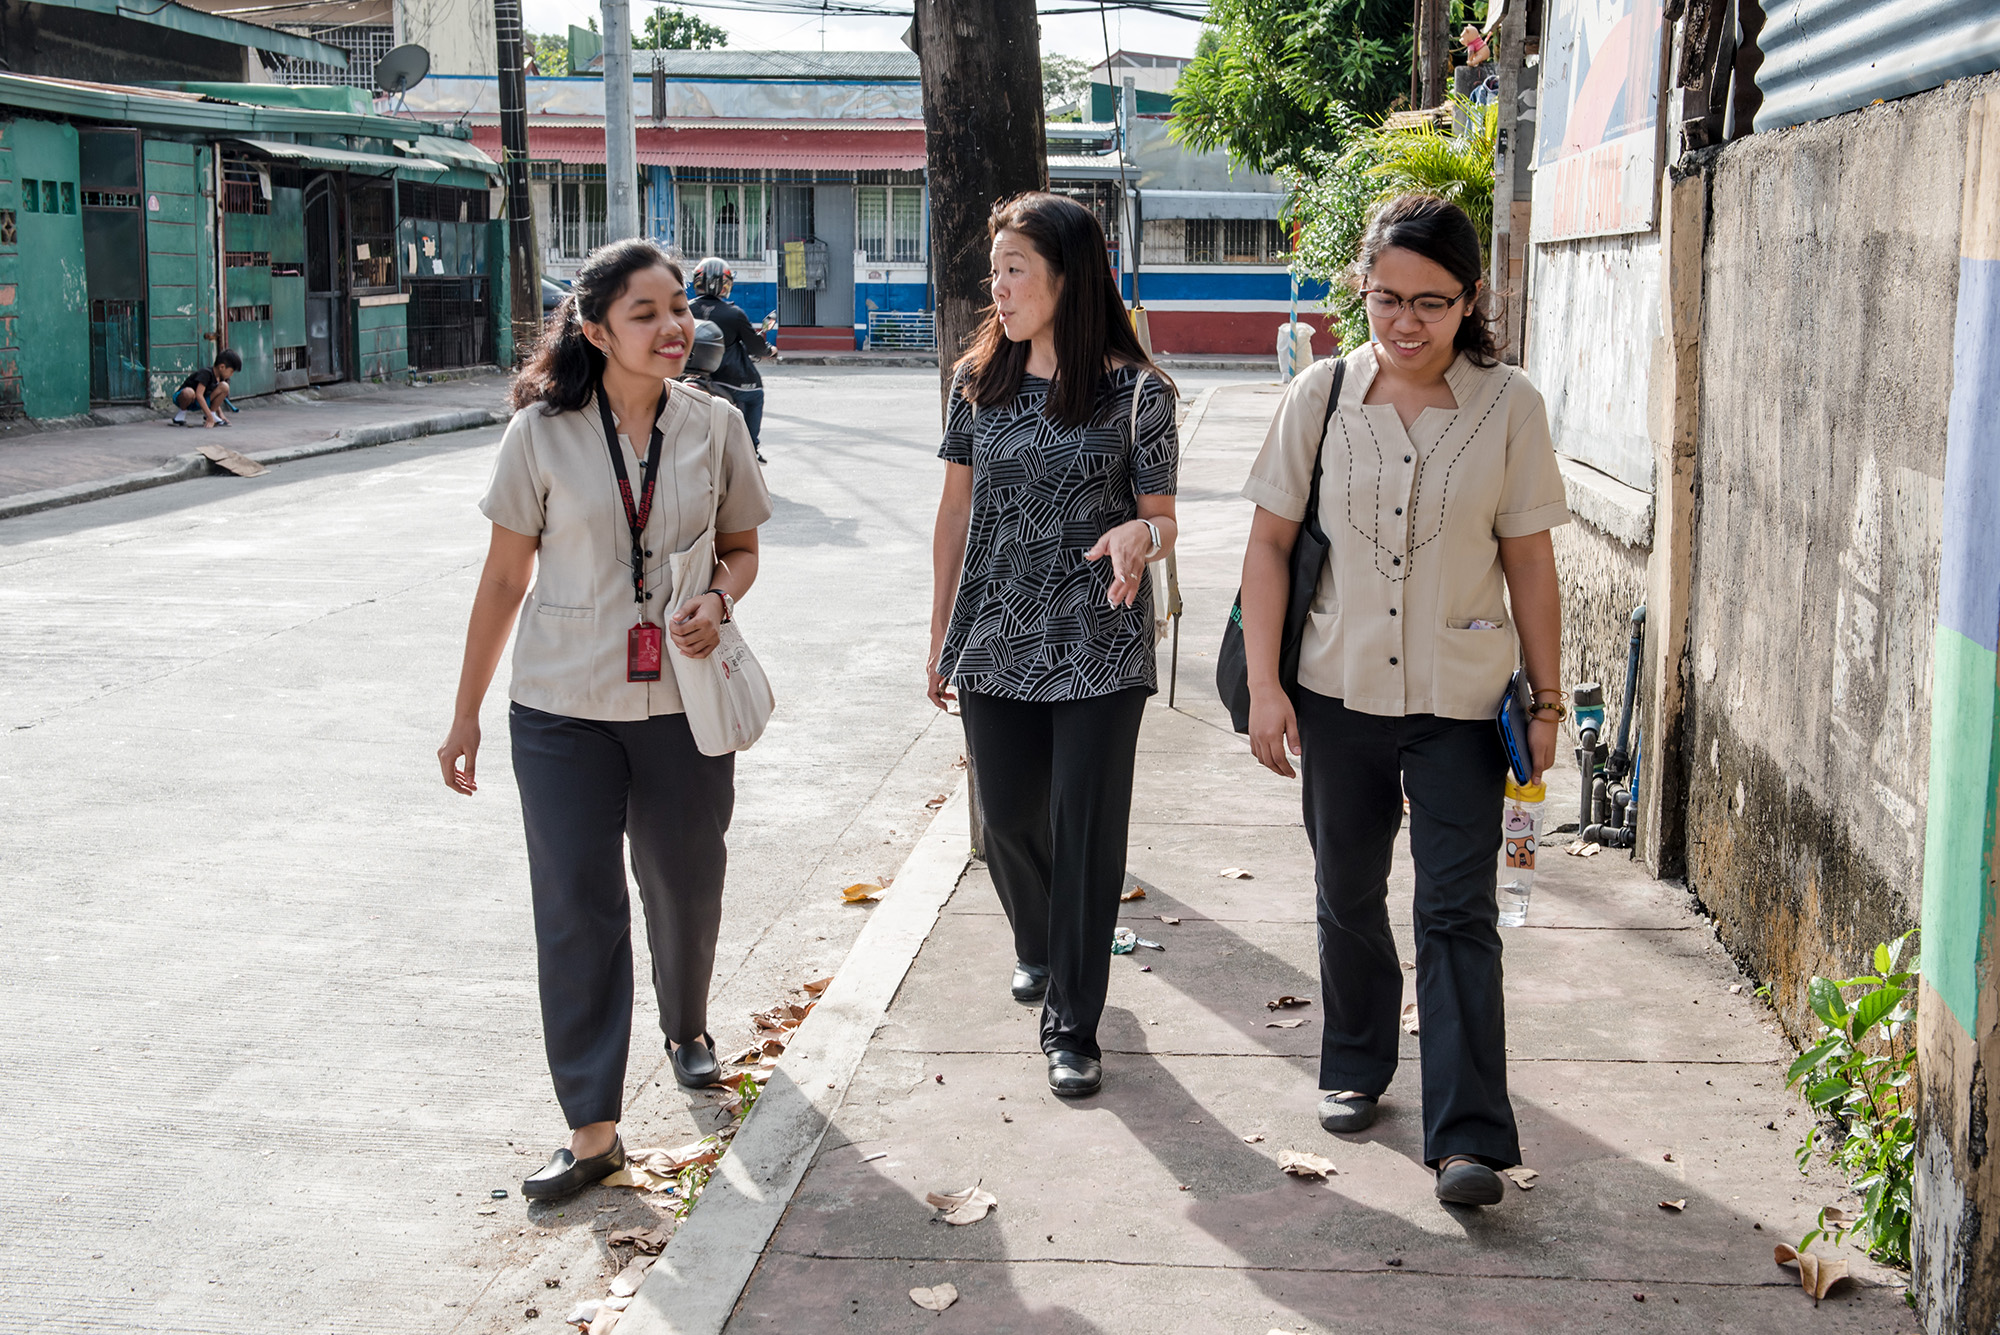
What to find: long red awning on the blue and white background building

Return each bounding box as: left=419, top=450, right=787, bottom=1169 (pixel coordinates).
left=472, top=126, right=924, bottom=172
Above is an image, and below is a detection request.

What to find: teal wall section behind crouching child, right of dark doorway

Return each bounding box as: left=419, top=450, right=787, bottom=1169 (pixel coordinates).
left=144, top=140, right=216, bottom=402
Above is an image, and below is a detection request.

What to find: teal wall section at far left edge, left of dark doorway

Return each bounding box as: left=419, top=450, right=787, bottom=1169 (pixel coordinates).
left=6, top=120, right=90, bottom=418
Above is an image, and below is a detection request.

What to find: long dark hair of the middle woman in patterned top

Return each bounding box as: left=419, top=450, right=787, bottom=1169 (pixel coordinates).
left=954, top=190, right=1174, bottom=428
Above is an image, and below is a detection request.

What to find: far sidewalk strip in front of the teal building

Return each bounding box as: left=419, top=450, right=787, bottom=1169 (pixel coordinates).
left=0, top=372, right=508, bottom=518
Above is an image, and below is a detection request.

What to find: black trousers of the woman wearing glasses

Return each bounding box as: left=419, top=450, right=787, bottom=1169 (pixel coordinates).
left=1298, top=689, right=1520, bottom=1167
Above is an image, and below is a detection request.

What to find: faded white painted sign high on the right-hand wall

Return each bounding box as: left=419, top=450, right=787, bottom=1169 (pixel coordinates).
left=1530, top=0, right=1660, bottom=242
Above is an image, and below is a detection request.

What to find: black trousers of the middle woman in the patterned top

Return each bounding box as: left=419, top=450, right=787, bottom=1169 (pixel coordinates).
left=958, top=685, right=1152, bottom=1057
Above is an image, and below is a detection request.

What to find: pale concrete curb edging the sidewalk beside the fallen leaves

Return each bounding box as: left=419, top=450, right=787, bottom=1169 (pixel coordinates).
left=618, top=779, right=972, bottom=1335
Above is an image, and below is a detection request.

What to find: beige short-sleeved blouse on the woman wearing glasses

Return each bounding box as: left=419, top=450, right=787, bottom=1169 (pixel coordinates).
left=1244, top=344, right=1570, bottom=719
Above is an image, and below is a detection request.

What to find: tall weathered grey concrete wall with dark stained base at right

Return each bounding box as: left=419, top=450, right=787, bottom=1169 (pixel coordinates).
left=1684, top=80, right=1978, bottom=1039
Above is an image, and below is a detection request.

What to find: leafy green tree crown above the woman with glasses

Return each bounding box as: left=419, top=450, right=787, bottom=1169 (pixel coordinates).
left=1174, top=0, right=1410, bottom=172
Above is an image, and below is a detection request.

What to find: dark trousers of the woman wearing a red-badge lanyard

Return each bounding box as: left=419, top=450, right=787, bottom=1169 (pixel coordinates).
left=508, top=703, right=736, bottom=1129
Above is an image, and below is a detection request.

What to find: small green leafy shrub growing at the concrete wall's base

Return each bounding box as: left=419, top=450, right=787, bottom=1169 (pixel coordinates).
left=1786, top=929, right=1918, bottom=1269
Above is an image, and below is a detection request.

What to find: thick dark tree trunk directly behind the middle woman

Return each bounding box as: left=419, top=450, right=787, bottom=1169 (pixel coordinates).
left=914, top=0, right=1048, bottom=394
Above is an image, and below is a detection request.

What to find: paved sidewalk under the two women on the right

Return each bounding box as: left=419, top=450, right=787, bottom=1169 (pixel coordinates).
left=646, top=386, right=1914, bottom=1335
